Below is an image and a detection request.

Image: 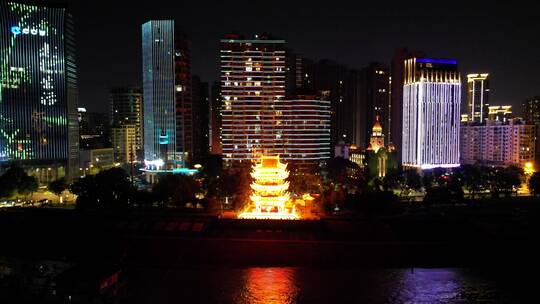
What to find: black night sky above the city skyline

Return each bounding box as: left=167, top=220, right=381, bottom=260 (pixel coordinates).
left=70, top=0, right=540, bottom=113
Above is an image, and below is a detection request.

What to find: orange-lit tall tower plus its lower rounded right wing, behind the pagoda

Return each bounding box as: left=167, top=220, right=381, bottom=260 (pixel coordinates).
left=221, top=35, right=331, bottom=165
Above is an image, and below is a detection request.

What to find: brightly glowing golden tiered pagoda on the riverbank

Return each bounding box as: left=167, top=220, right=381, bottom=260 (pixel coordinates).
left=238, top=156, right=298, bottom=220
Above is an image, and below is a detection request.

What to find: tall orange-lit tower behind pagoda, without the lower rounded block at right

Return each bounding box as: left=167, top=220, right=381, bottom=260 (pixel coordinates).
left=221, top=34, right=285, bottom=164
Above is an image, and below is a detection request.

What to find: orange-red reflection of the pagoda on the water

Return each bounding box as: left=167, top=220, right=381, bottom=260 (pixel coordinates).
left=234, top=268, right=298, bottom=304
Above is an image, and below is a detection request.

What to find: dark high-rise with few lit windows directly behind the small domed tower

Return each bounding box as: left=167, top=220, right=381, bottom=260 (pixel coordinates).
left=360, top=62, right=390, bottom=146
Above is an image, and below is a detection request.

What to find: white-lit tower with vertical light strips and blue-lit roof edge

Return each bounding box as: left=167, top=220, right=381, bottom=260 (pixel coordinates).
left=402, top=58, right=461, bottom=169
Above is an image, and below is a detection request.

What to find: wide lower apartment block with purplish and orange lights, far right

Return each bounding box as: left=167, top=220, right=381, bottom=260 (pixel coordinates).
left=460, top=119, right=535, bottom=167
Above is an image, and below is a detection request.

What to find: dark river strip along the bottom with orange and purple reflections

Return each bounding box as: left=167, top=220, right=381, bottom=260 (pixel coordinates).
left=121, top=267, right=534, bottom=304
